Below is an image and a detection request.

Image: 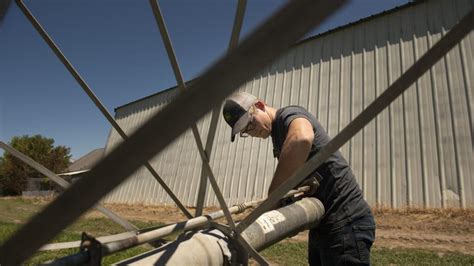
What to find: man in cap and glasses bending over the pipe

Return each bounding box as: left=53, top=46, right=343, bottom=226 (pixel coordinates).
left=223, top=92, right=375, bottom=265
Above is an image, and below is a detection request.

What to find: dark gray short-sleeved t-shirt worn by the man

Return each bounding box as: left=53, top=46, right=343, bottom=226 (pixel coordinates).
left=271, top=106, right=370, bottom=230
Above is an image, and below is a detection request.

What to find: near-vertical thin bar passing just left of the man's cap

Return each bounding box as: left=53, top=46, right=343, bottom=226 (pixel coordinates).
left=195, top=0, right=247, bottom=216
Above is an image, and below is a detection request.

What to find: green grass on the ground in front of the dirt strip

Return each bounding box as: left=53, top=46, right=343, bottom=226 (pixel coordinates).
left=0, top=198, right=474, bottom=265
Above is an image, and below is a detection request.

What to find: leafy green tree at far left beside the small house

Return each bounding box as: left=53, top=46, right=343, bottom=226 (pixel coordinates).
left=0, top=135, right=71, bottom=195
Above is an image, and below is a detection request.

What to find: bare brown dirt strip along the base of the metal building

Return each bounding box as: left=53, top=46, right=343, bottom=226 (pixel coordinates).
left=87, top=204, right=474, bottom=255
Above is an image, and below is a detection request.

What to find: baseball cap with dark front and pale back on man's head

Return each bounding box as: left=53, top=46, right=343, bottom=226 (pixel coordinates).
left=222, top=92, right=257, bottom=142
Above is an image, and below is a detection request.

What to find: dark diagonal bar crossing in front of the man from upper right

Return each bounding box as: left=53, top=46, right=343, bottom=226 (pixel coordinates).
left=237, top=7, right=474, bottom=232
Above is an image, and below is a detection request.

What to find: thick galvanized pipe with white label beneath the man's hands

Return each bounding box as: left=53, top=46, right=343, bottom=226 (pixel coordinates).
left=118, top=198, right=324, bottom=265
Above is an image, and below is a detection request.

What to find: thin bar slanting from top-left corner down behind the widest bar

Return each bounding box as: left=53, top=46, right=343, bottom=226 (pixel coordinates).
left=16, top=0, right=193, bottom=218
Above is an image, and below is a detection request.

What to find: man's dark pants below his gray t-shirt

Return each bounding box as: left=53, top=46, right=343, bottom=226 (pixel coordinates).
left=308, top=213, right=375, bottom=265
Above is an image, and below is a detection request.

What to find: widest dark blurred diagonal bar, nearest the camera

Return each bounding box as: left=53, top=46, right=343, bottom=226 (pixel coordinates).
left=0, top=0, right=346, bottom=265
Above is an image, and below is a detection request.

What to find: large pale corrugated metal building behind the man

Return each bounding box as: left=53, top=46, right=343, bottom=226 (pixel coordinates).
left=104, top=0, right=474, bottom=208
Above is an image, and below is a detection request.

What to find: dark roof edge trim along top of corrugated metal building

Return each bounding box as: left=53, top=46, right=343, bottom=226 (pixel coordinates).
left=114, top=0, right=427, bottom=112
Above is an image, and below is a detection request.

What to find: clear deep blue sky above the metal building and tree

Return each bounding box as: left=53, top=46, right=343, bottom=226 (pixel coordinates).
left=0, top=0, right=407, bottom=159
